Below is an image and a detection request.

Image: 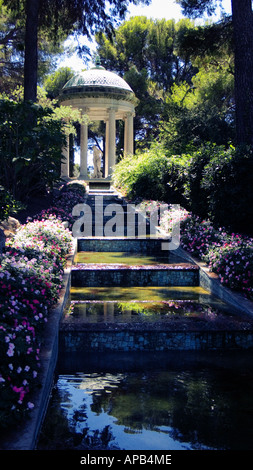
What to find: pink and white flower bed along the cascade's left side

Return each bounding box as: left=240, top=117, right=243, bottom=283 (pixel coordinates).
left=0, top=183, right=77, bottom=429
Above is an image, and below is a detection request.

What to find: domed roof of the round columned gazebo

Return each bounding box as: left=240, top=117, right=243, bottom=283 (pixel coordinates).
left=61, top=58, right=134, bottom=97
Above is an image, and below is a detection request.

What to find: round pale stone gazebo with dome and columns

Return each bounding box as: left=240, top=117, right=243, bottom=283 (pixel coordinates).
left=60, top=63, right=136, bottom=181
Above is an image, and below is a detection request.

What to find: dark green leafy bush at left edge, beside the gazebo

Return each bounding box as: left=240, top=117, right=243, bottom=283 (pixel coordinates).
left=0, top=98, right=65, bottom=201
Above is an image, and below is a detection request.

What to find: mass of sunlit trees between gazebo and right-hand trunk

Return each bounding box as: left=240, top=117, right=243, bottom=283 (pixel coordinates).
left=96, top=16, right=234, bottom=153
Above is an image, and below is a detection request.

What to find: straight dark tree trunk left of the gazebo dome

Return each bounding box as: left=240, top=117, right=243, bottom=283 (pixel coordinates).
left=24, top=0, right=40, bottom=102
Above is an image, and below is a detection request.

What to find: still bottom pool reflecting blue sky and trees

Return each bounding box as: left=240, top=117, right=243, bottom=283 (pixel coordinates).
left=37, top=351, right=253, bottom=450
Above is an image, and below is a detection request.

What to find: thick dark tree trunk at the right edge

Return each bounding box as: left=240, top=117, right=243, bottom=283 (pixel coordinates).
left=232, top=0, right=253, bottom=145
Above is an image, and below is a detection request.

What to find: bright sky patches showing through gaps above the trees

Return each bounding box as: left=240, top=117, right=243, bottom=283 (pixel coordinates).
left=58, top=0, right=231, bottom=72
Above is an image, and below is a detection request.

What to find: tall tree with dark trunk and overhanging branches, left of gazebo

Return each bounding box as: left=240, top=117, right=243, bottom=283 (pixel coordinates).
left=4, top=0, right=150, bottom=101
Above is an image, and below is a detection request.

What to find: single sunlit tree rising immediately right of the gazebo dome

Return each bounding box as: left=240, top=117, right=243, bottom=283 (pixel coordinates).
left=96, top=16, right=197, bottom=147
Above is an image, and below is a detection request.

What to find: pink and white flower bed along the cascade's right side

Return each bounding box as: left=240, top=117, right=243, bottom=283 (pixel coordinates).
left=151, top=201, right=253, bottom=300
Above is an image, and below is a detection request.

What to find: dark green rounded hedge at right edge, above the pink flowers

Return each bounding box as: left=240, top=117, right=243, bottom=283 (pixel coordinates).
left=186, top=144, right=253, bottom=234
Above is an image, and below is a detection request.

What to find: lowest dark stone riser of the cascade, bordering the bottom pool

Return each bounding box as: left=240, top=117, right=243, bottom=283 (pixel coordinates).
left=59, top=330, right=253, bottom=354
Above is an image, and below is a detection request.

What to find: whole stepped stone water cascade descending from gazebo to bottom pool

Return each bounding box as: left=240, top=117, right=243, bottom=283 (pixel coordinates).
left=59, top=190, right=253, bottom=354
